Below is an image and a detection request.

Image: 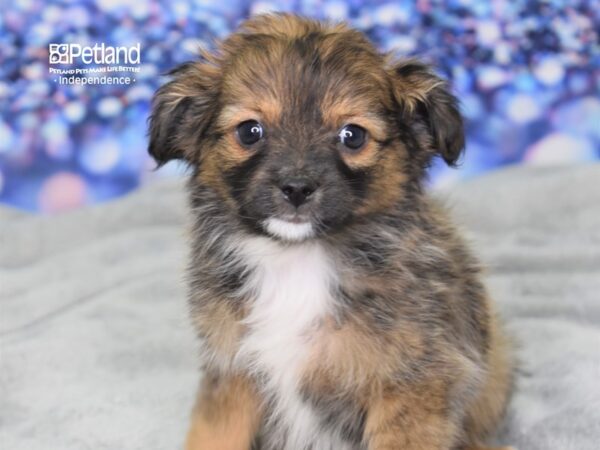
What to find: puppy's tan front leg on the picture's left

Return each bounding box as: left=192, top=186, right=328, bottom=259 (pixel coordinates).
left=185, top=374, right=262, bottom=450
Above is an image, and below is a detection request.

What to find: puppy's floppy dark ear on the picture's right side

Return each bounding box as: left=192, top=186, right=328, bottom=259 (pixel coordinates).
left=393, top=60, right=465, bottom=166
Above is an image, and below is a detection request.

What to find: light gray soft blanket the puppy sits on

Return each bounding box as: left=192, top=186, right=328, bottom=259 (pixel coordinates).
left=0, top=166, right=600, bottom=450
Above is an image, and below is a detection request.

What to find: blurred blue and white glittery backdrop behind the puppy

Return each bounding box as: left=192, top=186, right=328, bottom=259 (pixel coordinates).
left=0, top=0, right=600, bottom=213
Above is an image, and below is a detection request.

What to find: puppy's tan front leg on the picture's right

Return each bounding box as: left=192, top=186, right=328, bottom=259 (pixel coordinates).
left=364, top=385, right=459, bottom=450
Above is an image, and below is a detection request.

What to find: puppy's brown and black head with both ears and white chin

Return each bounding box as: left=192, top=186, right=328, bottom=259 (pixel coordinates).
left=149, top=15, right=464, bottom=241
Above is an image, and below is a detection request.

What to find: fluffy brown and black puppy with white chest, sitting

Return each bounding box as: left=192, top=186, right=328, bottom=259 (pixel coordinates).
left=149, top=15, right=511, bottom=450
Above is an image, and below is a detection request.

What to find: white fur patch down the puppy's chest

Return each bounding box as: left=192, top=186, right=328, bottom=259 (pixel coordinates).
left=237, top=237, right=344, bottom=450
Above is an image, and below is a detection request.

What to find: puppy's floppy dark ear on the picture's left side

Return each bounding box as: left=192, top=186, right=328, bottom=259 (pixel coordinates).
left=148, top=62, right=219, bottom=167
